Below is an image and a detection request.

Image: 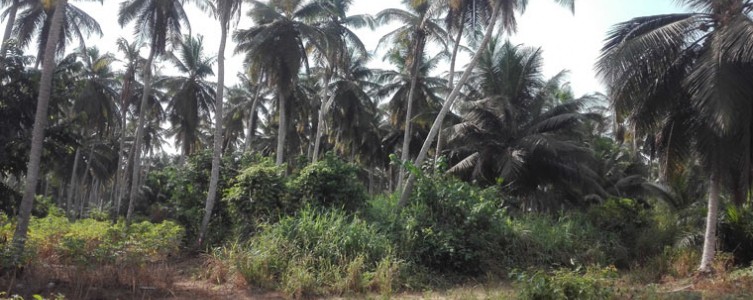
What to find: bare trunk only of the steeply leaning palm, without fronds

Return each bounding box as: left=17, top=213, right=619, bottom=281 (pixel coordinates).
left=398, top=5, right=500, bottom=207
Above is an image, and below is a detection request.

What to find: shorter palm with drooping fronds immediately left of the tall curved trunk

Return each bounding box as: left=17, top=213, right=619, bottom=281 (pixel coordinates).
left=155, top=36, right=216, bottom=158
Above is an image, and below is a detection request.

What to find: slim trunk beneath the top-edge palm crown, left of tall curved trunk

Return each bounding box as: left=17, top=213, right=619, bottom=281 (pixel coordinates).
left=126, top=47, right=157, bottom=226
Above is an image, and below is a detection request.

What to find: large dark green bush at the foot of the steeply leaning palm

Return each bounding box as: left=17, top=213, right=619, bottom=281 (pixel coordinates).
left=367, top=177, right=508, bottom=275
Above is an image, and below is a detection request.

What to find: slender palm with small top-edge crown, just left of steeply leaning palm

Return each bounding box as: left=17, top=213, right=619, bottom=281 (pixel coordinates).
left=376, top=1, right=447, bottom=188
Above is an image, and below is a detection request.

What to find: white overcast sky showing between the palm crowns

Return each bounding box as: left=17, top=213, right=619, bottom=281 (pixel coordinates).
left=0, top=0, right=682, bottom=95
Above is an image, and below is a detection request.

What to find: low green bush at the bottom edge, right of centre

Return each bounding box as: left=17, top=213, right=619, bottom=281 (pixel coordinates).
left=512, top=267, right=617, bottom=299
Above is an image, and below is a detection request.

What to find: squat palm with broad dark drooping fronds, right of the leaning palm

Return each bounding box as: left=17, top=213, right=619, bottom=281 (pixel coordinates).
left=447, top=38, right=607, bottom=209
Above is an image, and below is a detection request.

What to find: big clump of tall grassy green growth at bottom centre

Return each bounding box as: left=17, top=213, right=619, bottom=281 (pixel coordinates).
left=215, top=208, right=400, bottom=297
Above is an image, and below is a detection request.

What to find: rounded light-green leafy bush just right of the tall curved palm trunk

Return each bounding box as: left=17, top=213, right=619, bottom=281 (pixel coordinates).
left=222, top=159, right=293, bottom=236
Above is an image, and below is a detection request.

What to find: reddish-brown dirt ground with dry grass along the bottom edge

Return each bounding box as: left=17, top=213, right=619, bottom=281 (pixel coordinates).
left=0, top=257, right=753, bottom=300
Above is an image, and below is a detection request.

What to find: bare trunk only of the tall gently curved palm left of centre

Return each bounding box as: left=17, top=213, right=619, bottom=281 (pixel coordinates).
left=197, top=18, right=228, bottom=245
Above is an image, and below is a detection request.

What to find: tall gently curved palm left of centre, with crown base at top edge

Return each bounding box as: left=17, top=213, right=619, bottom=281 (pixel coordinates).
left=198, top=0, right=242, bottom=244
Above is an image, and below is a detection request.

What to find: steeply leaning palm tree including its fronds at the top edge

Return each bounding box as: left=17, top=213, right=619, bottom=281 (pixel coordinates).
left=398, top=0, right=575, bottom=207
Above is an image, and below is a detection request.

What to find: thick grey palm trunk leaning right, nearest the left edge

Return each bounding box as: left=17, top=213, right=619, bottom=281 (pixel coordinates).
left=13, top=0, right=68, bottom=263
